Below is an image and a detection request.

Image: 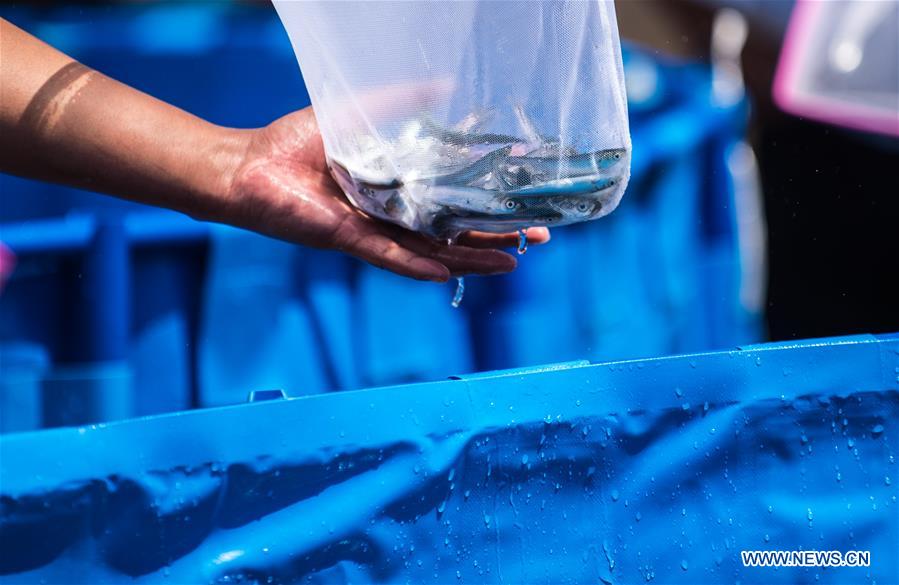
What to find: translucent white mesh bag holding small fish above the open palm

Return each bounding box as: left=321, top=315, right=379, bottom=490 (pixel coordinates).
left=275, top=0, right=630, bottom=239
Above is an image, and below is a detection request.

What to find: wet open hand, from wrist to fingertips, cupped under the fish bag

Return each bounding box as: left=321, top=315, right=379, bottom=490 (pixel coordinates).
left=220, top=108, right=549, bottom=282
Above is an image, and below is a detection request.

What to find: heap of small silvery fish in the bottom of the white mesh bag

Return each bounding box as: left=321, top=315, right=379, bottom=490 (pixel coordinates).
left=329, top=108, right=630, bottom=238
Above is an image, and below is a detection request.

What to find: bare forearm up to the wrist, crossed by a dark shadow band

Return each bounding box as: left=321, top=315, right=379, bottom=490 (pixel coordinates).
left=0, top=19, right=249, bottom=219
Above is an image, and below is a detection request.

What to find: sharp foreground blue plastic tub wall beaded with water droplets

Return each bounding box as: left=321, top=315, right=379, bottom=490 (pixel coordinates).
left=0, top=335, right=899, bottom=585
